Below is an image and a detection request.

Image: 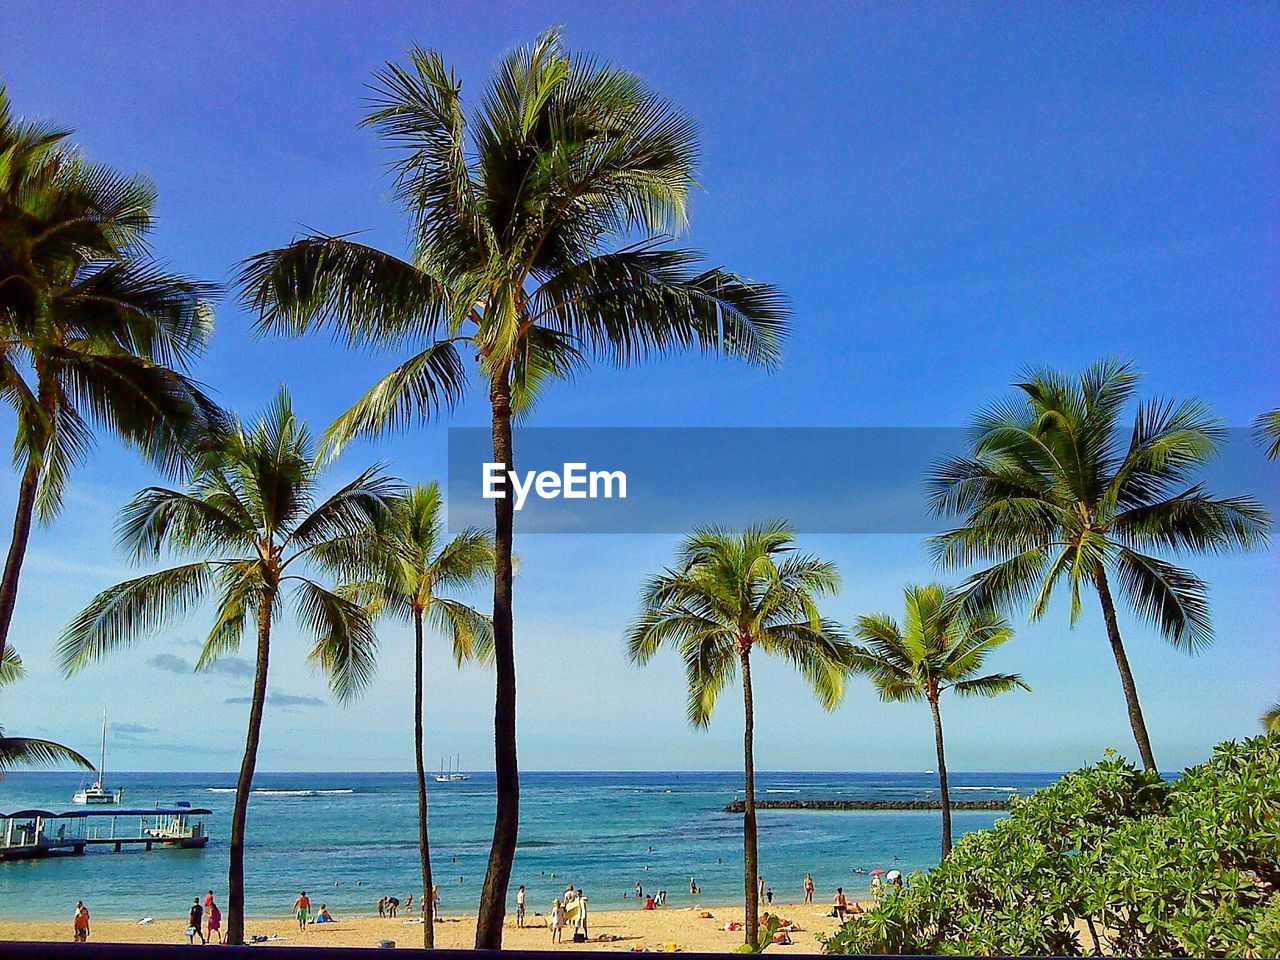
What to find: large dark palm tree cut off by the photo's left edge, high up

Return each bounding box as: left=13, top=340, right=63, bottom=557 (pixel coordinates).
left=0, top=88, right=220, bottom=670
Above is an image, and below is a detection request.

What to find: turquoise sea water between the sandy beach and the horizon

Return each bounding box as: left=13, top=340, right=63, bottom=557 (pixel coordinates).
left=0, top=772, right=1055, bottom=920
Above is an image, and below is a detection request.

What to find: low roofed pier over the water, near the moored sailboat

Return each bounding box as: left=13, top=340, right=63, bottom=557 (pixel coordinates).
left=0, top=804, right=212, bottom=861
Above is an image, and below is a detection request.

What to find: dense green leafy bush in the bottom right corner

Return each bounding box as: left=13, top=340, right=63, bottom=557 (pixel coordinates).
left=826, top=736, right=1280, bottom=956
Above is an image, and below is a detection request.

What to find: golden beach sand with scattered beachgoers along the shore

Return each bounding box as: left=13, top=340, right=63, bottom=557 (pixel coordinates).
left=0, top=904, right=837, bottom=954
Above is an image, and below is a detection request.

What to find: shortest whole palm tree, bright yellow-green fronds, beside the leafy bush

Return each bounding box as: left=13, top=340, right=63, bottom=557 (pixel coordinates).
left=852, top=584, right=1030, bottom=859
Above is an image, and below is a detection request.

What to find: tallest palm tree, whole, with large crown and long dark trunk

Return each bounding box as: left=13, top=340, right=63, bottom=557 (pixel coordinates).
left=241, top=32, right=787, bottom=948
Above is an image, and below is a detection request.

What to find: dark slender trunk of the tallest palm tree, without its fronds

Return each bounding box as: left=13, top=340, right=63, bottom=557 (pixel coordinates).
left=476, top=370, right=520, bottom=950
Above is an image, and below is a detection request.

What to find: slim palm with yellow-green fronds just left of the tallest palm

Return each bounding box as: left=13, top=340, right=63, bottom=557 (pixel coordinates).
left=333, top=483, right=493, bottom=948
